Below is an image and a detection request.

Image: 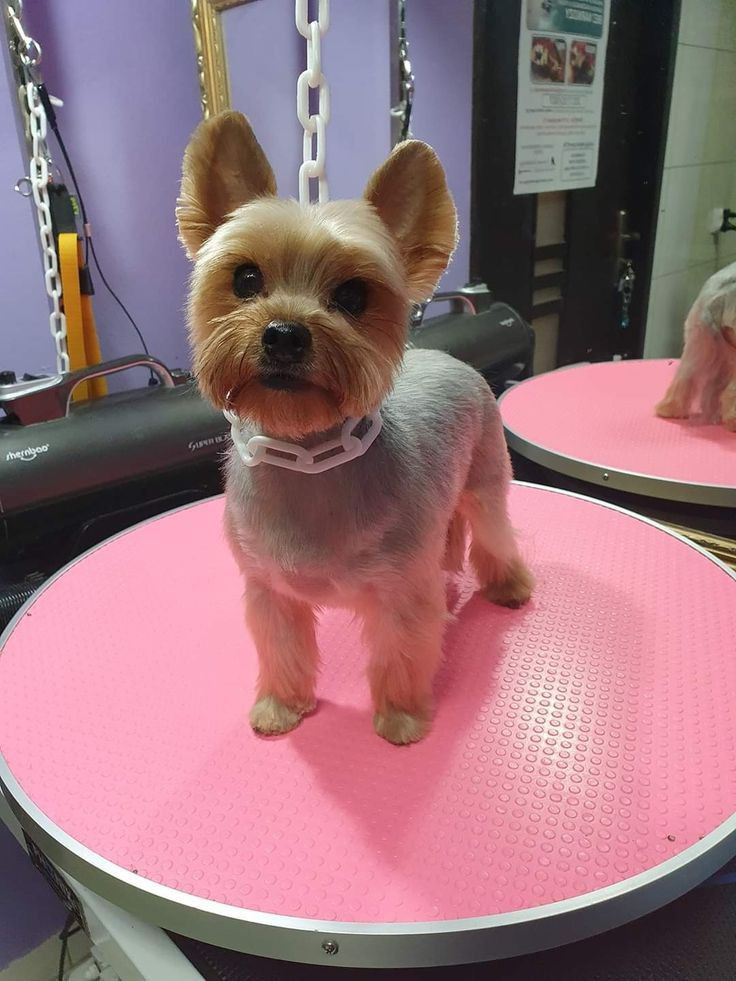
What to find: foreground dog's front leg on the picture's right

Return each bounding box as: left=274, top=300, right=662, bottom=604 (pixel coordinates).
left=361, top=575, right=447, bottom=744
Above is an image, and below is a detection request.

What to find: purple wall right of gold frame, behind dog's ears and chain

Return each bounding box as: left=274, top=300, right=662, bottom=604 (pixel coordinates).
left=224, top=0, right=473, bottom=289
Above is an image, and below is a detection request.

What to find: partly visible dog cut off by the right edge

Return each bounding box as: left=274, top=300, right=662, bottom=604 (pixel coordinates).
left=655, top=262, right=736, bottom=432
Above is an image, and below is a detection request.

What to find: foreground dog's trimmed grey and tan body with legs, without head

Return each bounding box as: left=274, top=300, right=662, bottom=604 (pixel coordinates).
left=227, top=351, right=531, bottom=742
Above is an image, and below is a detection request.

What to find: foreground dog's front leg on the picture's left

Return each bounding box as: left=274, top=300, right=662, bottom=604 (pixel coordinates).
left=245, top=577, right=319, bottom=736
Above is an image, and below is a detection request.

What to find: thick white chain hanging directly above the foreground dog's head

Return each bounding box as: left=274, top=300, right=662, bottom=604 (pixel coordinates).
left=295, top=0, right=330, bottom=204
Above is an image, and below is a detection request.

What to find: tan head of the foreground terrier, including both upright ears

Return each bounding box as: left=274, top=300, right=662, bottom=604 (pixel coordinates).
left=176, top=112, right=457, bottom=438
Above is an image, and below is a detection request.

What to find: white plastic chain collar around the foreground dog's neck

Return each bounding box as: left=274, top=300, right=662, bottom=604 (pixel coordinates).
left=225, top=411, right=383, bottom=473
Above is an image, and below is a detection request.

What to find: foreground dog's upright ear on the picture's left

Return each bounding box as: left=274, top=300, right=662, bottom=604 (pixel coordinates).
left=176, top=110, right=276, bottom=259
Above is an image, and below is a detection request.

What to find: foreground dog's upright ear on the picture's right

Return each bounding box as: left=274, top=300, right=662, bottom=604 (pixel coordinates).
left=365, top=140, right=457, bottom=303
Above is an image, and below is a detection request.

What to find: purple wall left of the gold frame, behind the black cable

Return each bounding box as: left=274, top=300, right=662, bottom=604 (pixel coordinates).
left=15, top=0, right=200, bottom=378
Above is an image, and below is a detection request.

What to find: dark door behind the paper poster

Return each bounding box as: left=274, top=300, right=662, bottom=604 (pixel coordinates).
left=471, top=0, right=679, bottom=364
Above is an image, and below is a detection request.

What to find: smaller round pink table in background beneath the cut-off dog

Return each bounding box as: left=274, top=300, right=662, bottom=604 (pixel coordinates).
left=500, top=361, right=736, bottom=507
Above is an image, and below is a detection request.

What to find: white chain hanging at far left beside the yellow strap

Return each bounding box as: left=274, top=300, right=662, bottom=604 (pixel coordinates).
left=7, top=0, right=70, bottom=373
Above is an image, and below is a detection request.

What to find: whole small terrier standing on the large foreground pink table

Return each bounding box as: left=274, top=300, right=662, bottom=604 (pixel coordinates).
left=177, top=112, right=532, bottom=744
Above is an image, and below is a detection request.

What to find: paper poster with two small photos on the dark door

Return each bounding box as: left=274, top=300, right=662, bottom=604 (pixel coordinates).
left=514, top=0, right=611, bottom=194
